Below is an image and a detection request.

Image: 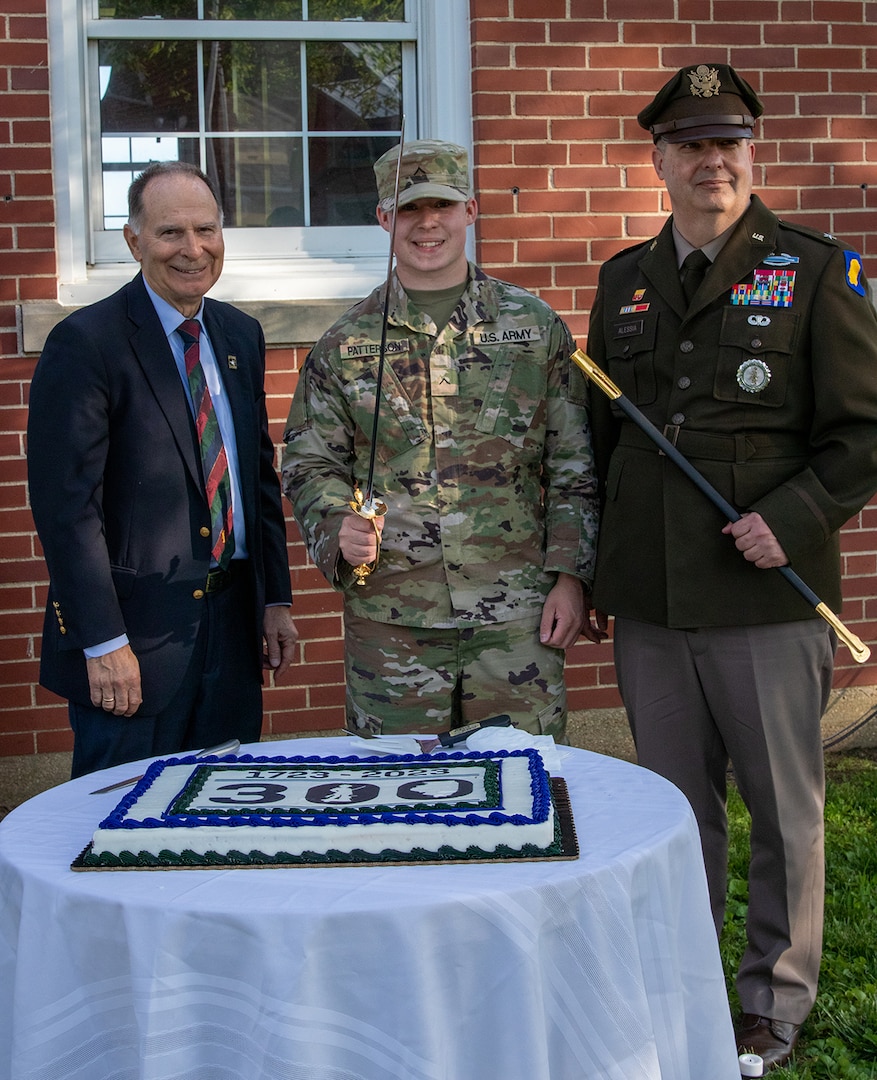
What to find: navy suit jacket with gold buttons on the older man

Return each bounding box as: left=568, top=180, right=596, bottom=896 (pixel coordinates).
left=27, top=274, right=291, bottom=715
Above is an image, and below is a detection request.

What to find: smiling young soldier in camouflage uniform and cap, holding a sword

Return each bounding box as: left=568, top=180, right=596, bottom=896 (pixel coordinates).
left=283, top=140, right=597, bottom=738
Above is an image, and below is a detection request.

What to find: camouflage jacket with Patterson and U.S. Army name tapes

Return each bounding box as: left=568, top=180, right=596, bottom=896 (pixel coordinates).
left=282, top=265, right=597, bottom=629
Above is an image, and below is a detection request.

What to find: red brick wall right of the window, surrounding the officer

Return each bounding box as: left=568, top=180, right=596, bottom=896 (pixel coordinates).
left=471, top=0, right=877, bottom=708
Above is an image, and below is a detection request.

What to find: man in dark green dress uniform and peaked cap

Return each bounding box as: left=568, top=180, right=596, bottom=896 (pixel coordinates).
left=589, top=64, right=877, bottom=1066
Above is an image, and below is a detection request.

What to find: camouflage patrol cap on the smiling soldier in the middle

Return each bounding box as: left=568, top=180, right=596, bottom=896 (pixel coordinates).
left=375, top=139, right=472, bottom=210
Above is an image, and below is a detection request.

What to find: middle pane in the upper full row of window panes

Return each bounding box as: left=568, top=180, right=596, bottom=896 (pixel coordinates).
left=204, top=41, right=301, bottom=132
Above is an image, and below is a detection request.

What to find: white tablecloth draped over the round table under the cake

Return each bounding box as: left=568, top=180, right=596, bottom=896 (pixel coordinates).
left=0, top=738, right=740, bottom=1080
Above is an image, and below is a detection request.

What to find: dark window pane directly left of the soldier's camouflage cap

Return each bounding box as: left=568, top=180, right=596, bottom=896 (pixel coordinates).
left=310, top=136, right=397, bottom=226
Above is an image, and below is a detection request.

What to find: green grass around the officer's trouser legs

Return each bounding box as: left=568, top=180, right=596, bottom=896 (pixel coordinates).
left=721, top=751, right=877, bottom=1080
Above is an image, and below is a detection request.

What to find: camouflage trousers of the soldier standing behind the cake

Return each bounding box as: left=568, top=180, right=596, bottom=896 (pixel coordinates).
left=345, top=611, right=566, bottom=742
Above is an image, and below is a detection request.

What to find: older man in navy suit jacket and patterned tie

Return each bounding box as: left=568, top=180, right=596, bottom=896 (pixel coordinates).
left=28, top=162, right=298, bottom=777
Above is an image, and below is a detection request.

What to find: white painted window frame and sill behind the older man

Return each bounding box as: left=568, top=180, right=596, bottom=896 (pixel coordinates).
left=49, top=0, right=472, bottom=305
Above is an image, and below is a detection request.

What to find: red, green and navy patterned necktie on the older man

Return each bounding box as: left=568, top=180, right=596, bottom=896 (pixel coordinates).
left=177, top=319, right=234, bottom=569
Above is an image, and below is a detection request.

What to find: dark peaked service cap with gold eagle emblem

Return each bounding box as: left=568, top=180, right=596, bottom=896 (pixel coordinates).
left=636, top=64, right=765, bottom=143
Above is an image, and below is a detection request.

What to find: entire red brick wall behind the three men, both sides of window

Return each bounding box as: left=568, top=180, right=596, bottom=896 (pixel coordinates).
left=0, top=0, right=877, bottom=755
